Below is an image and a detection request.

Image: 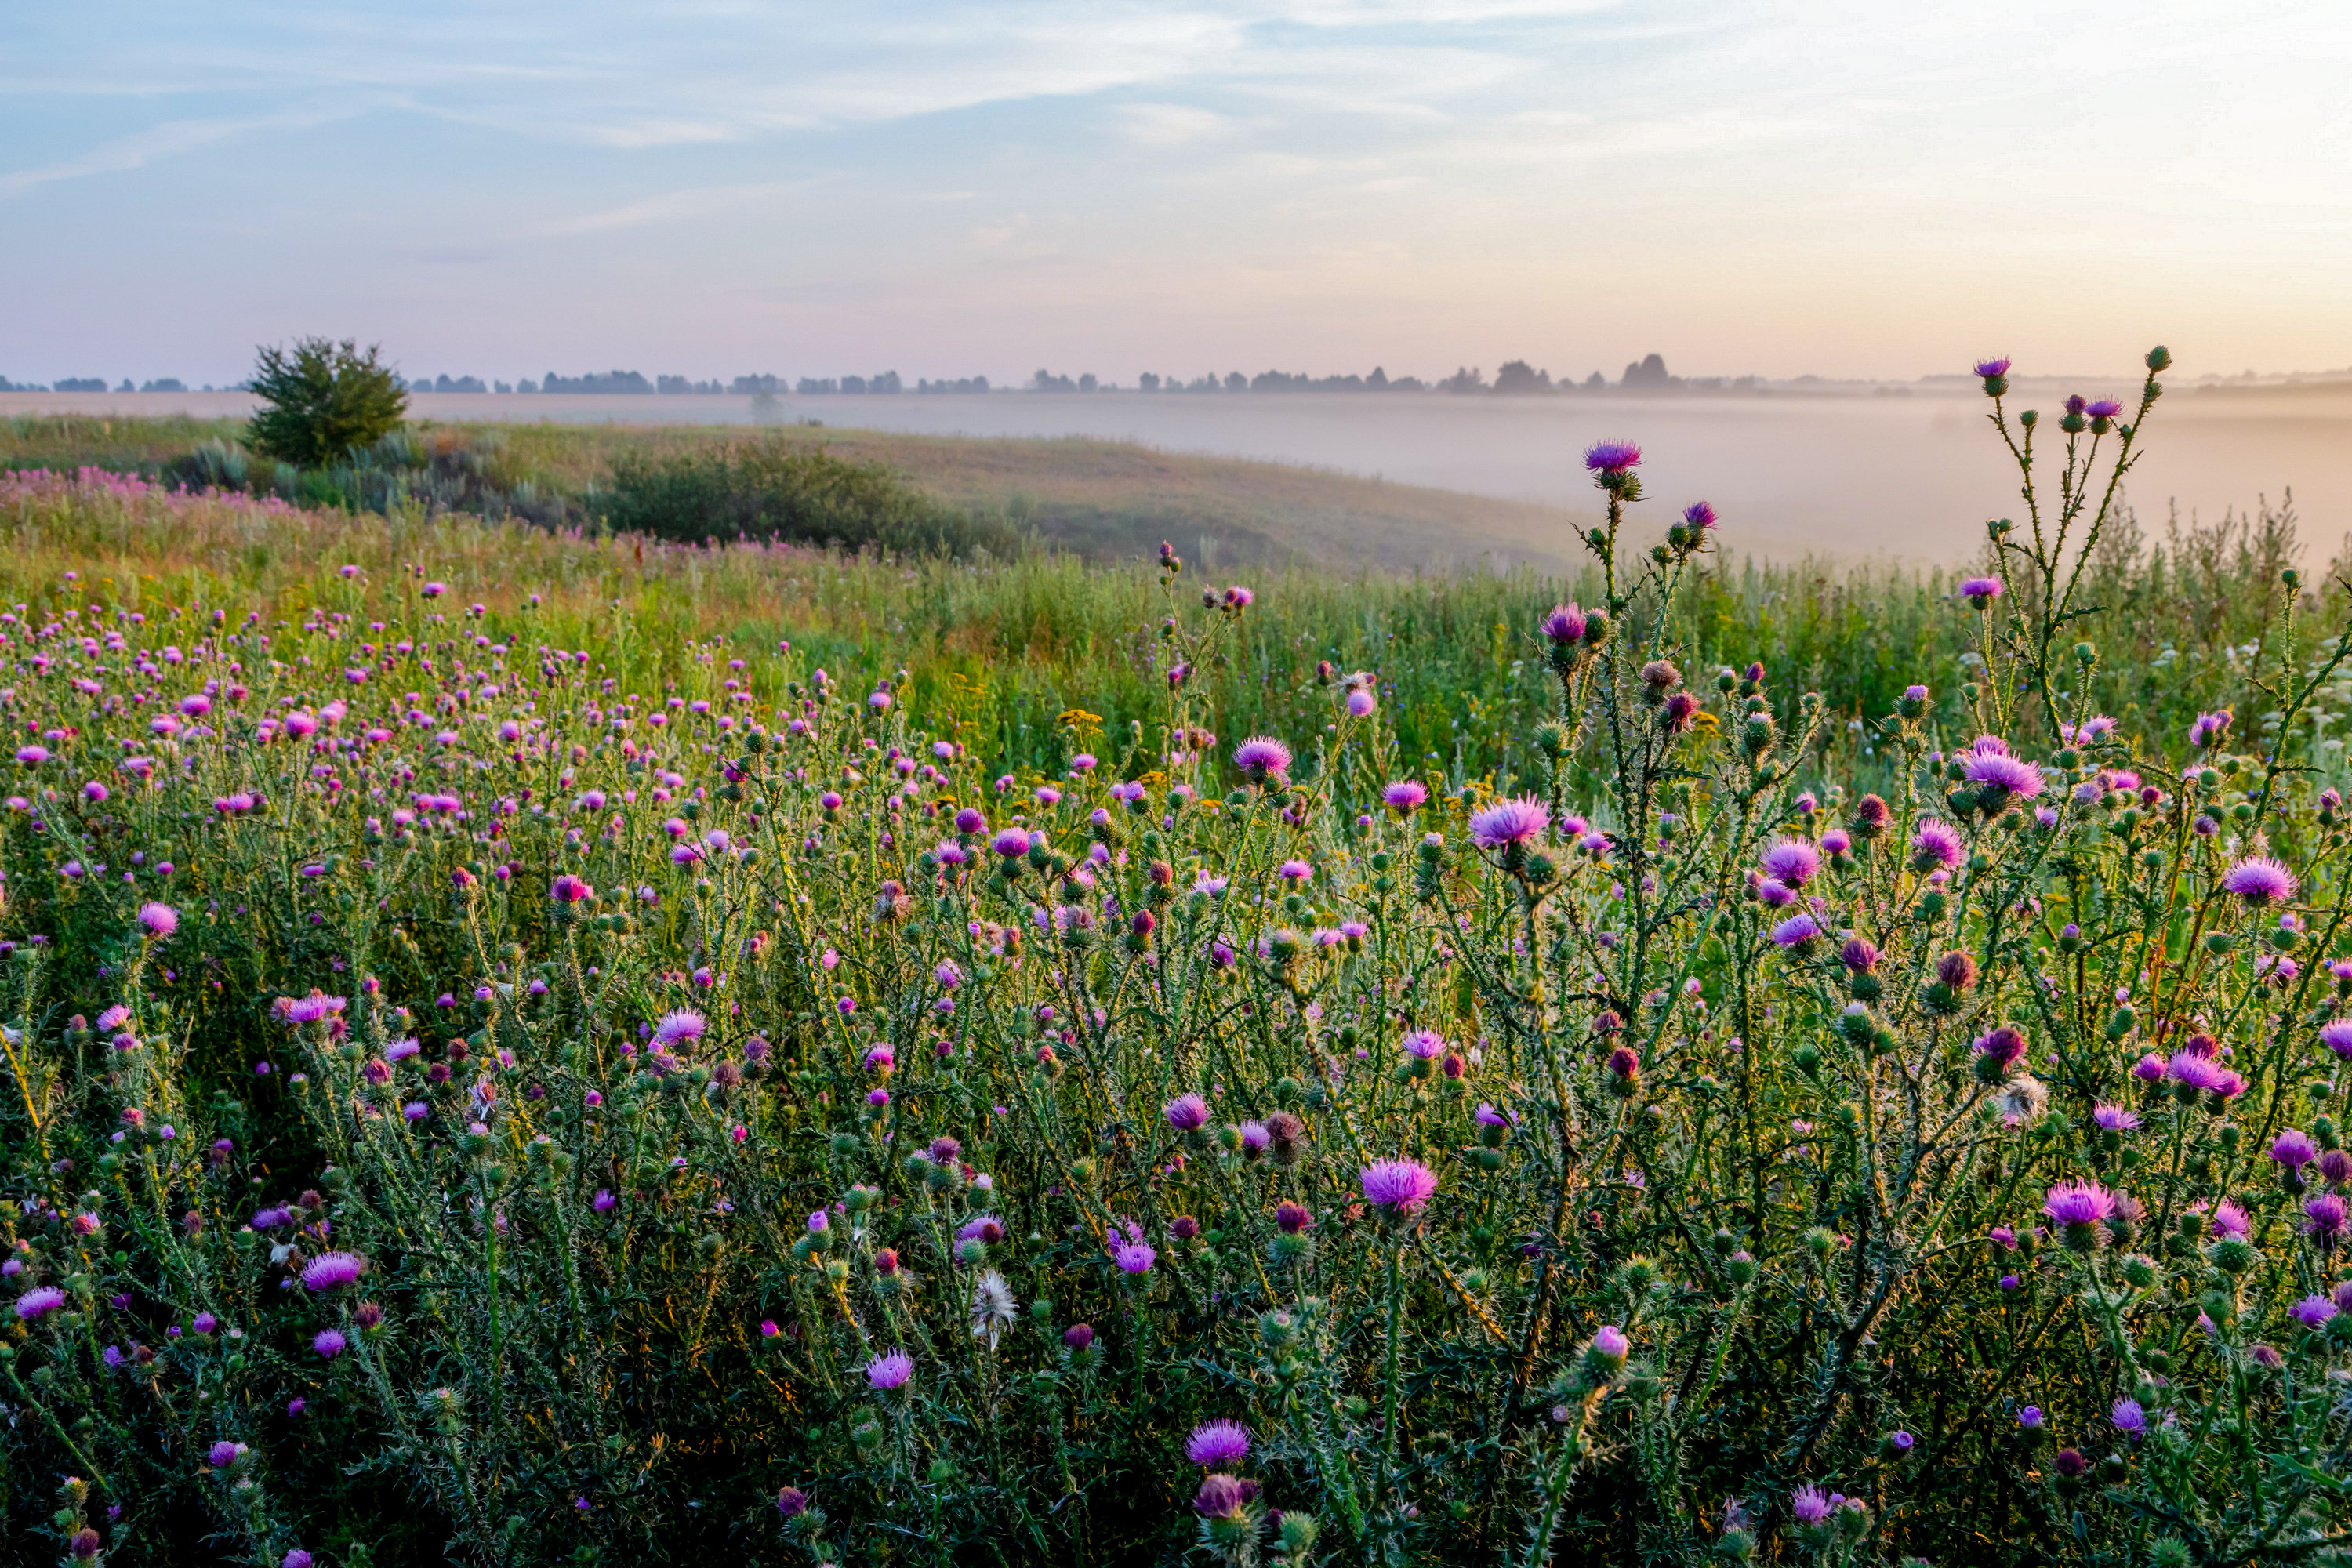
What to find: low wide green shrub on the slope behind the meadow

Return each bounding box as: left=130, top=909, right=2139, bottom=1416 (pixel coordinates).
left=602, top=437, right=1021, bottom=557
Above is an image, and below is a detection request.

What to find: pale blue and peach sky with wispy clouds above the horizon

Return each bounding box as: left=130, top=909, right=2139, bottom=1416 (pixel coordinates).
left=13, top=0, right=2352, bottom=386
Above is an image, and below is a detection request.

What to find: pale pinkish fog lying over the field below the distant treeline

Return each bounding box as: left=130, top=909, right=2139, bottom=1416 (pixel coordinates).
left=13, top=381, right=2352, bottom=564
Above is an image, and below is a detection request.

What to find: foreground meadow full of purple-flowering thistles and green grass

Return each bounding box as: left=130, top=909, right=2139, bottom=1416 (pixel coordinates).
left=0, top=350, right=2352, bottom=1568
